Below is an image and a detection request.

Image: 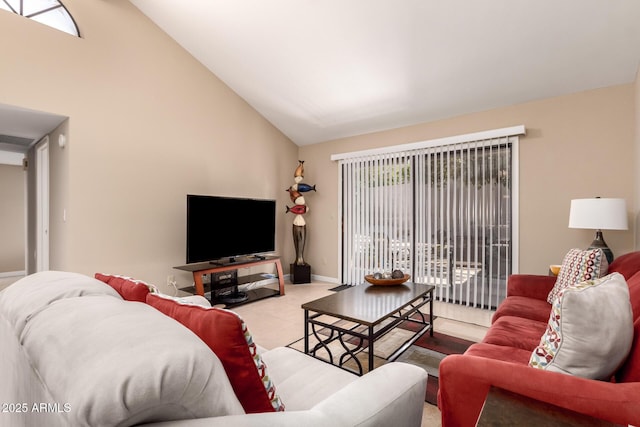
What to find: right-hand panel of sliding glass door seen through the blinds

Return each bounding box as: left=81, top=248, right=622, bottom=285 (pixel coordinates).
left=413, top=143, right=513, bottom=307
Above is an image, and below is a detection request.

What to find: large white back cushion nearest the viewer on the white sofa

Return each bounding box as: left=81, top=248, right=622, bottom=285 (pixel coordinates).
left=21, top=296, right=244, bottom=426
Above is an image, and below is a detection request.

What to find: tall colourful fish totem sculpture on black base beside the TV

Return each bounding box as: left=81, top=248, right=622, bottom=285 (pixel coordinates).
left=286, top=160, right=316, bottom=284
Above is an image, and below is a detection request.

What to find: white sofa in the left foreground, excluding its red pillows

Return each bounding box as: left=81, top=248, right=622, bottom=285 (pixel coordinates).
left=0, top=272, right=427, bottom=427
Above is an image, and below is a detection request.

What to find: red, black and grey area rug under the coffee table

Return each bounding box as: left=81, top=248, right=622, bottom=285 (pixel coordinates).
left=288, top=320, right=473, bottom=405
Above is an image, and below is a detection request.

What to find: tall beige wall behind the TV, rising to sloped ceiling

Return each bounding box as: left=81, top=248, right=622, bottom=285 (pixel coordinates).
left=0, top=0, right=298, bottom=292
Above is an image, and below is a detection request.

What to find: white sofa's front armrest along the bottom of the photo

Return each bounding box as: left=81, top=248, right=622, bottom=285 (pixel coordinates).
left=142, top=362, right=427, bottom=427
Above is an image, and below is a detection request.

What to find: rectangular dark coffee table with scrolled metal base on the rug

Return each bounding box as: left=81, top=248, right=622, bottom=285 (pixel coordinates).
left=302, top=282, right=434, bottom=375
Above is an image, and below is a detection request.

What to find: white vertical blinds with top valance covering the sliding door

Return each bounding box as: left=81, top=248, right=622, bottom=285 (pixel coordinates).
left=332, top=127, right=524, bottom=308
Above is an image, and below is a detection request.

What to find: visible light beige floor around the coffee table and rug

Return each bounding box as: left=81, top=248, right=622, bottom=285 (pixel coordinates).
left=0, top=277, right=492, bottom=427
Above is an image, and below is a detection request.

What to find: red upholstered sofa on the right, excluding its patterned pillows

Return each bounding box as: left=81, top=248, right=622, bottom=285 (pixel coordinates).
left=438, top=252, right=640, bottom=427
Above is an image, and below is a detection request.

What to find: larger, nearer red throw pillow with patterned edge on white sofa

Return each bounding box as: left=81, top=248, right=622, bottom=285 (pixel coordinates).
left=147, top=294, right=284, bottom=414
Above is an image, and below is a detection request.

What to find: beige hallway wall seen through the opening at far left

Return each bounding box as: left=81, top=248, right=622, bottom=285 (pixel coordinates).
left=0, top=164, right=26, bottom=273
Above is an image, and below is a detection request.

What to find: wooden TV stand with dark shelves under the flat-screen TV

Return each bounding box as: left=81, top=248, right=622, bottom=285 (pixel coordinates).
left=174, top=256, right=284, bottom=306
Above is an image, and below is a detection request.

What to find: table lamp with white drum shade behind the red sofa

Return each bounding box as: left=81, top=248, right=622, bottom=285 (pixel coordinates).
left=569, top=197, right=629, bottom=263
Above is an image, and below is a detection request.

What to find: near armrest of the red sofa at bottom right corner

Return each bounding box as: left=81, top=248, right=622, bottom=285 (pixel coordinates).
left=438, top=355, right=640, bottom=427
